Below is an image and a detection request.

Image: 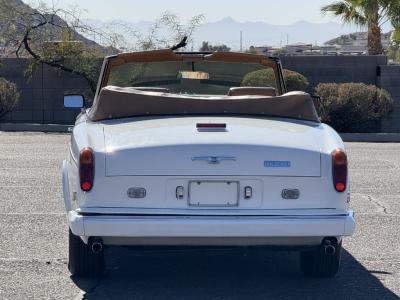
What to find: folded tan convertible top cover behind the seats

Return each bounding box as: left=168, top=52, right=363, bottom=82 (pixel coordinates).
left=89, top=86, right=319, bottom=122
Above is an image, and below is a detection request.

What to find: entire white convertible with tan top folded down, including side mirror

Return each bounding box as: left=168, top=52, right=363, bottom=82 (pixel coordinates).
left=63, top=50, right=355, bottom=277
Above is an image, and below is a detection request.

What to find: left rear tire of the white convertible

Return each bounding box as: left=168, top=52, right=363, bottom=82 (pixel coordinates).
left=68, top=229, right=104, bottom=277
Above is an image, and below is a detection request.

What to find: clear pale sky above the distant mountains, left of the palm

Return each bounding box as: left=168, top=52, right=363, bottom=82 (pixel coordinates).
left=24, top=0, right=335, bottom=24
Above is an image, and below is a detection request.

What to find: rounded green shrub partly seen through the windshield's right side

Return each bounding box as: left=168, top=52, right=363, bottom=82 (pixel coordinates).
left=242, top=69, right=309, bottom=92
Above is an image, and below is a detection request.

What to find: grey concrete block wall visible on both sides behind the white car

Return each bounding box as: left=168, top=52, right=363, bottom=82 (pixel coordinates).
left=0, top=56, right=400, bottom=132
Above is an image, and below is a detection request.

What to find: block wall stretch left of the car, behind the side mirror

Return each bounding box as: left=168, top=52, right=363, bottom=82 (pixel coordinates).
left=0, top=58, right=88, bottom=124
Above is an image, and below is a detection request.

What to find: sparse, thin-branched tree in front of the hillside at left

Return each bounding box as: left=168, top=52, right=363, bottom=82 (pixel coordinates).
left=0, top=0, right=204, bottom=94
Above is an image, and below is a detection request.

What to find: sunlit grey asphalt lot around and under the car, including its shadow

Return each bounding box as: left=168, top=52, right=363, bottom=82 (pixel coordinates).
left=0, top=132, right=400, bottom=299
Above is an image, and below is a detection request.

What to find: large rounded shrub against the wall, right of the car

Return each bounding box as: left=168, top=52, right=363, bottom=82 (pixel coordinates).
left=315, top=83, right=393, bottom=132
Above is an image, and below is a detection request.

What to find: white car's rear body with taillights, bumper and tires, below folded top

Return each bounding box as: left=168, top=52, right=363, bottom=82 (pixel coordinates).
left=63, top=49, right=355, bottom=277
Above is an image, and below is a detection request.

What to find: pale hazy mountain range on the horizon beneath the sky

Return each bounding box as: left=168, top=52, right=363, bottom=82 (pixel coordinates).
left=89, top=17, right=357, bottom=50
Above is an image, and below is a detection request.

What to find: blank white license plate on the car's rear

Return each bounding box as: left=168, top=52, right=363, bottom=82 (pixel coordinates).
left=189, top=181, right=239, bottom=207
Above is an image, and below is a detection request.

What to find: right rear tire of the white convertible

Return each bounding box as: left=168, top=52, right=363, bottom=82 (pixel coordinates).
left=300, top=243, right=342, bottom=278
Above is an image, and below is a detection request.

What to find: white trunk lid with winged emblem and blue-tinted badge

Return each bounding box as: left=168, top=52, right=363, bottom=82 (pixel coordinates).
left=104, top=117, right=321, bottom=177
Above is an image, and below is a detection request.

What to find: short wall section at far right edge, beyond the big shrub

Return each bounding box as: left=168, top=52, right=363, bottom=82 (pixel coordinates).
left=379, top=65, right=400, bottom=132
